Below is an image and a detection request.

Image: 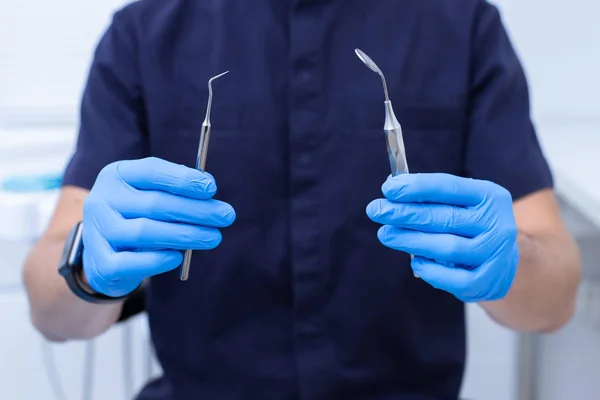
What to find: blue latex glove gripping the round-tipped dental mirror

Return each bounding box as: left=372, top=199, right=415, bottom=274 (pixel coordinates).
left=367, top=174, right=519, bottom=302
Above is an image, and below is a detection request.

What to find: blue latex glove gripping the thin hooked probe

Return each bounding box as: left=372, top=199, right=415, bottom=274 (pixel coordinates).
left=83, top=158, right=235, bottom=297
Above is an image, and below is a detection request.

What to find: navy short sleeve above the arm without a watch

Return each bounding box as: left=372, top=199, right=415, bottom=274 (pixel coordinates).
left=465, top=1, right=553, bottom=200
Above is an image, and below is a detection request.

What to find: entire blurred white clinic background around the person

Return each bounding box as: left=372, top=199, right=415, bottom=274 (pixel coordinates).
left=0, top=0, right=600, bottom=400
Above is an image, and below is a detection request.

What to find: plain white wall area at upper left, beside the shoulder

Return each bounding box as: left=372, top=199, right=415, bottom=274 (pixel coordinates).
left=0, top=0, right=125, bottom=127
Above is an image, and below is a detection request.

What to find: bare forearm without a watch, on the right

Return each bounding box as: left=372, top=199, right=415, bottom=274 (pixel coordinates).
left=481, top=232, right=581, bottom=332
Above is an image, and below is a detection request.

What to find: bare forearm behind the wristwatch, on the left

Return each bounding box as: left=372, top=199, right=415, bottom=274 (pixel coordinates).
left=24, top=237, right=123, bottom=341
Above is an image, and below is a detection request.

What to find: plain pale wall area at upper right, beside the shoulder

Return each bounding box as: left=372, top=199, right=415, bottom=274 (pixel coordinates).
left=495, top=0, right=600, bottom=122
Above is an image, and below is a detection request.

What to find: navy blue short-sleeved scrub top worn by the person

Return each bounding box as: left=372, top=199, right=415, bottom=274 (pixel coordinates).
left=64, top=0, right=552, bottom=400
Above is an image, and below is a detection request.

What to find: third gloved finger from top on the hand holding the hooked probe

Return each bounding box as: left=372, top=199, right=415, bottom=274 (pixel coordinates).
left=104, top=218, right=222, bottom=250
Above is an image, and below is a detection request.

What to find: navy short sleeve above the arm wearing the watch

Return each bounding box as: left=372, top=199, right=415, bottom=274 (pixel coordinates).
left=63, top=8, right=147, bottom=189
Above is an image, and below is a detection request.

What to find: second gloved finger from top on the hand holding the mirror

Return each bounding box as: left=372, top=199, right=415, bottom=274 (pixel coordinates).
left=367, top=199, right=487, bottom=237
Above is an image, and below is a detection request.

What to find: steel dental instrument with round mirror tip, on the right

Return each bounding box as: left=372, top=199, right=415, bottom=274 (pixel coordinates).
left=354, top=49, right=418, bottom=278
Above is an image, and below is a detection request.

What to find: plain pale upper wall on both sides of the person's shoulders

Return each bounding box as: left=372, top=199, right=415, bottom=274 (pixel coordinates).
left=0, top=0, right=600, bottom=126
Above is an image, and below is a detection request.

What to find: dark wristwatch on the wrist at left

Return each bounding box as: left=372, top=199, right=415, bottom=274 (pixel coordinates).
left=58, top=221, right=130, bottom=304
